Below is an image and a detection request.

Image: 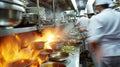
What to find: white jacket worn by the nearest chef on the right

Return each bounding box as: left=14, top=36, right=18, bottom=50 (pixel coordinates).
left=88, top=8, right=120, bottom=56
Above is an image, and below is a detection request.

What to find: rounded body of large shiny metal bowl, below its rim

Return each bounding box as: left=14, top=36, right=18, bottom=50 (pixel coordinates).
left=0, top=9, right=22, bottom=27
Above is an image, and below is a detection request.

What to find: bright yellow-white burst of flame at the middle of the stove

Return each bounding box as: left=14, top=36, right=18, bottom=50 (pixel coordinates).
left=35, top=28, right=65, bottom=49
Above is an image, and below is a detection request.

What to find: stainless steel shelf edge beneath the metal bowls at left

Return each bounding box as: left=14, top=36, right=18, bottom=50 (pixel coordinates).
left=0, top=26, right=37, bottom=36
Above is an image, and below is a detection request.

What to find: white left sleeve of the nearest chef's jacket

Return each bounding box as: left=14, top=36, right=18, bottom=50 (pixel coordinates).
left=87, top=17, right=103, bottom=42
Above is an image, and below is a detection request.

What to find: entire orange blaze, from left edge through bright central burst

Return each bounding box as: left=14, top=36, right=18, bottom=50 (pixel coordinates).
left=0, top=28, right=65, bottom=67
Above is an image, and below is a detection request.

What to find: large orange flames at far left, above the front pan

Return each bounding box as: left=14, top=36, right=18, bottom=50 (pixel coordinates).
left=0, top=35, right=41, bottom=67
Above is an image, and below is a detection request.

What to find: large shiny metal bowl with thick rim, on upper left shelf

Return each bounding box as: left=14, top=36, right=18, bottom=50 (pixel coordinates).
left=0, top=0, right=25, bottom=27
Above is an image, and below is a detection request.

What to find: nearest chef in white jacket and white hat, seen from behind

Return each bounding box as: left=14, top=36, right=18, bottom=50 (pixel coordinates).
left=88, top=0, right=120, bottom=67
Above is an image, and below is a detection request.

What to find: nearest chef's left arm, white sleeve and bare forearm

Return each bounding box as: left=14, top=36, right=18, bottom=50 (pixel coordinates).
left=87, top=17, right=103, bottom=50
